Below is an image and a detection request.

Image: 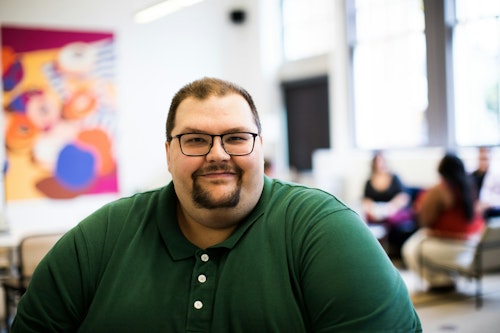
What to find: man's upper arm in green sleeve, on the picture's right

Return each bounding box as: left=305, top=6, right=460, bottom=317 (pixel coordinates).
left=302, top=209, right=421, bottom=332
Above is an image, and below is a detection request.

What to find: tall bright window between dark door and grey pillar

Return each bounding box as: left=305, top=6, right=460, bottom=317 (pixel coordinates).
left=348, top=0, right=428, bottom=149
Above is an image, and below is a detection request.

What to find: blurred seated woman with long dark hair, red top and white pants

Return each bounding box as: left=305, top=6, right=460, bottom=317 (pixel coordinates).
left=402, top=154, right=484, bottom=292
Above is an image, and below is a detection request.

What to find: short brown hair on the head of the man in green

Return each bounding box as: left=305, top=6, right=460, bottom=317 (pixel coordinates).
left=165, top=77, right=262, bottom=141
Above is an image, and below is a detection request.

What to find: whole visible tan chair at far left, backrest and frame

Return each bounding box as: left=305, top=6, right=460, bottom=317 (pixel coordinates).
left=2, top=233, right=63, bottom=330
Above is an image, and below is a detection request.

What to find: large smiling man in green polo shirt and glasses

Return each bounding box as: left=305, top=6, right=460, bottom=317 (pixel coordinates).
left=13, top=78, right=421, bottom=333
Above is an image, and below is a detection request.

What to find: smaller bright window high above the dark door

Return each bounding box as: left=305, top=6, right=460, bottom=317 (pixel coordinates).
left=281, top=0, right=334, bottom=61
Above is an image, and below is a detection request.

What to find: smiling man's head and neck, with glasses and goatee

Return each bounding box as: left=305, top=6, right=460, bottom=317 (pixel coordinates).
left=166, top=88, right=264, bottom=248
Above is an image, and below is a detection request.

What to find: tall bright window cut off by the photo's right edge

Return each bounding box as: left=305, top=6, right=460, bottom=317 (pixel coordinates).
left=453, top=0, right=500, bottom=146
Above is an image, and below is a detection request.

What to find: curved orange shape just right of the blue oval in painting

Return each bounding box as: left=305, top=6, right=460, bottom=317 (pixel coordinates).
left=77, top=128, right=115, bottom=175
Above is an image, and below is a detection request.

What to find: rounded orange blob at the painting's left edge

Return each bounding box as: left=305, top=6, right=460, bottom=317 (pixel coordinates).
left=5, top=113, right=38, bottom=151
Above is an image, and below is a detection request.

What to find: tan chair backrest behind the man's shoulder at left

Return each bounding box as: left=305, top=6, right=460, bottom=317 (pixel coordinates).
left=19, top=233, right=63, bottom=281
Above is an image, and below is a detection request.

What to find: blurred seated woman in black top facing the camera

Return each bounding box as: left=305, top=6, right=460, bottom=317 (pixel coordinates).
left=362, top=151, right=416, bottom=258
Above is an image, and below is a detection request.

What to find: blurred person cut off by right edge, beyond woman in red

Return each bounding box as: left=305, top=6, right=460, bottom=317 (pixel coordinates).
left=471, top=147, right=500, bottom=218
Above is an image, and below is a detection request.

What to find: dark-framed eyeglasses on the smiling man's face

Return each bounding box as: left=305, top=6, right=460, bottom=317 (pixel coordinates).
left=173, top=132, right=258, bottom=156
